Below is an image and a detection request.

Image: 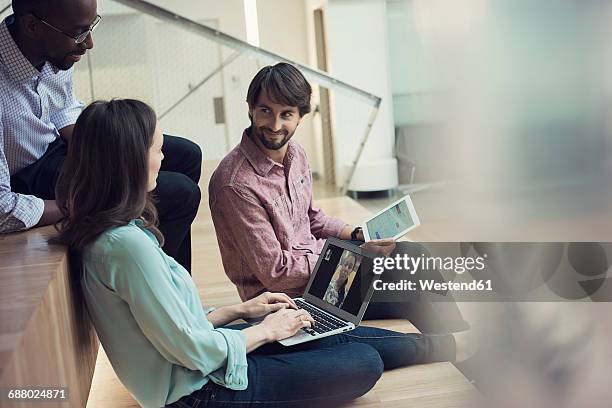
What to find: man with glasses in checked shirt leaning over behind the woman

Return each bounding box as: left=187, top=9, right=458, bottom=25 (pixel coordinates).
left=0, top=0, right=202, bottom=270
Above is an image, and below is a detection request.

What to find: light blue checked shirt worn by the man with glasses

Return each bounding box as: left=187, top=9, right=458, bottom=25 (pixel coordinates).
left=0, top=16, right=83, bottom=233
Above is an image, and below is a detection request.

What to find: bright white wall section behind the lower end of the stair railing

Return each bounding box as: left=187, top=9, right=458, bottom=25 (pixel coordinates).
left=327, top=0, right=394, bottom=186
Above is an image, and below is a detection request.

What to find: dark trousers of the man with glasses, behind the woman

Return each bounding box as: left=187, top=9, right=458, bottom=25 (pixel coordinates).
left=11, top=135, right=202, bottom=271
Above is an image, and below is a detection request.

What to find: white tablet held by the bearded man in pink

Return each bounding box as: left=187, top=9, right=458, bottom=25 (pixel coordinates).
left=362, top=196, right=421, bottom=242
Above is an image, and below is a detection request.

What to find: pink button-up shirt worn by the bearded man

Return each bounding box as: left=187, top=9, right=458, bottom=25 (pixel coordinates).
left=208, top=131, right=346, bottom=300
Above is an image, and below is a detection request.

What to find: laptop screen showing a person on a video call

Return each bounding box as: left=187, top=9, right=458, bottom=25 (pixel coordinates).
left=309, top=245, right=374, bottom=316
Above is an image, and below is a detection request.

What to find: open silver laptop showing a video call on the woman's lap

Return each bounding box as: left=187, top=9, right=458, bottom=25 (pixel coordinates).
left=279, top=238, right=375, bottom=346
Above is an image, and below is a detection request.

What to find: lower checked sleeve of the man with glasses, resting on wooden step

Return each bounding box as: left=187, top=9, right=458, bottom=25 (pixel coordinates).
left=0, top=109, right=45, bottom=234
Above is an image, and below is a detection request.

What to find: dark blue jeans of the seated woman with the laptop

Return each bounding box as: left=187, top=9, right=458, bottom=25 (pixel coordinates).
left=169, top=325, right=455, bottom=408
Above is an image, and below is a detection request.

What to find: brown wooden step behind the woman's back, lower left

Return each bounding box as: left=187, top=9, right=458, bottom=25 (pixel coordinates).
left=0, top=227, right=98, bottom=407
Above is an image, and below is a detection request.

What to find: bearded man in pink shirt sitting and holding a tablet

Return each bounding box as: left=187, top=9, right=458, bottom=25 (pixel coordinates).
left=208, top=63, right=468, bottom=332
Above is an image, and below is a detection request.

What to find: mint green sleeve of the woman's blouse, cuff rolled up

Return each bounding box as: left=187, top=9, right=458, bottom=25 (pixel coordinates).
left=106, top=233, right=248, bottom=390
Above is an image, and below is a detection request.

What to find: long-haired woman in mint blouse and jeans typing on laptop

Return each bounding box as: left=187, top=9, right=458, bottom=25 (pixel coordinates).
left=57, top=100, right=470, bottom=407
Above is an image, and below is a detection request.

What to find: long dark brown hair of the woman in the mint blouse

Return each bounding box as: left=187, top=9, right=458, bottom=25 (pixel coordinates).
left=55, top=99, right=163, bottom=255
